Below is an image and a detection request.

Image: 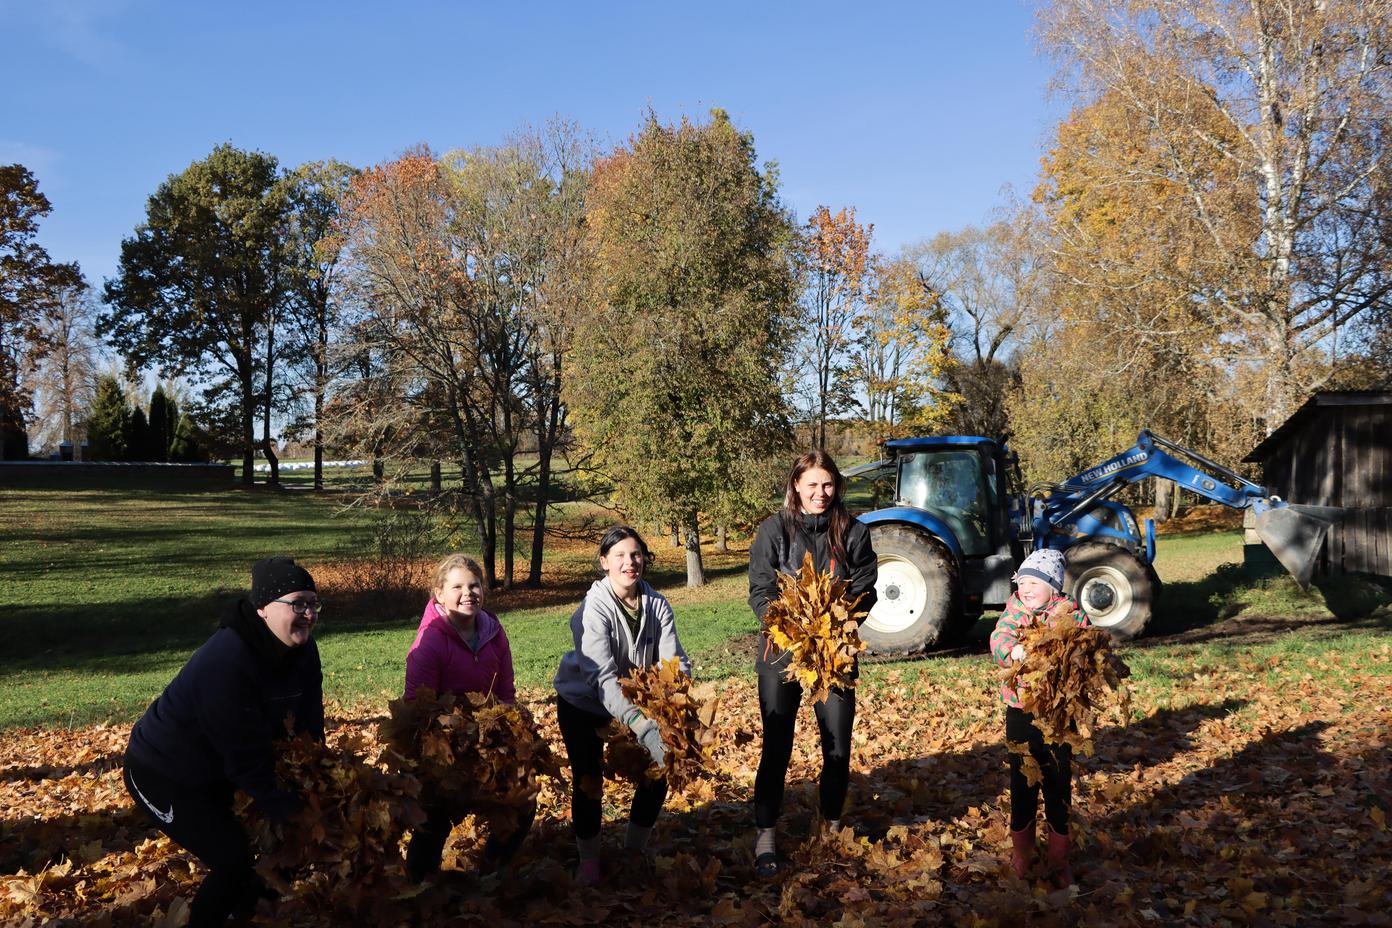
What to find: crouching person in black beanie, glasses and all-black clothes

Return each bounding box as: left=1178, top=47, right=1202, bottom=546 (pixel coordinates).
left=125, top=558, right=324, bottom=928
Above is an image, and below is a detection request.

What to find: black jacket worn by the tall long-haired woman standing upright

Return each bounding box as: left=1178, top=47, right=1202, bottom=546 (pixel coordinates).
left=749, top=512, right=877, bottom=671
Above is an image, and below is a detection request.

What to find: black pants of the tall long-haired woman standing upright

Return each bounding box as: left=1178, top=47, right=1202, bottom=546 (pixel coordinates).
left=754, top=666, right=856, bottom=828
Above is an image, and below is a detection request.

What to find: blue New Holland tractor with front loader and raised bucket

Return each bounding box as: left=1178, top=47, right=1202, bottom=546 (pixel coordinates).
left=860, top=431, right=1338, bottom=654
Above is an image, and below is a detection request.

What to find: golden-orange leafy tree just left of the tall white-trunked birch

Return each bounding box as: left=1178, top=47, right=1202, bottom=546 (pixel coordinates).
left=1012, top=77, right=1267, bottom=486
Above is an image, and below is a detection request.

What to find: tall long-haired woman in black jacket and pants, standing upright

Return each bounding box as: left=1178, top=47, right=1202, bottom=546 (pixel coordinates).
left=749, top=451, right=876, bottom=877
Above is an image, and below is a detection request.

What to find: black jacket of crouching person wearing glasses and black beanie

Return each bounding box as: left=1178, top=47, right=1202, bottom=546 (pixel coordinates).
left=125, top=600, right=324, bottom=818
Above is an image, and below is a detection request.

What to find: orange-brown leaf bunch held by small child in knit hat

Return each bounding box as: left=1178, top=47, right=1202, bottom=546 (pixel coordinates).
left=1005, top=607, right=1130, bottom=757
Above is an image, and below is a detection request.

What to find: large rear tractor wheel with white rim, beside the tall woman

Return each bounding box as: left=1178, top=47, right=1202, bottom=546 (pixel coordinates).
left=860, top=525, right=959, bottom=654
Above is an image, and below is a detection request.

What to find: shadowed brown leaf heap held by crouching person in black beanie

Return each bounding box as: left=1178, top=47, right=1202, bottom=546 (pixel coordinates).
left=238, top=735, right=425, bottom=924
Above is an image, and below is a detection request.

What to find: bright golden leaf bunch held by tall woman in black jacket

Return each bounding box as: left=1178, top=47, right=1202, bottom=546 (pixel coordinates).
left=764, top=552, right=866, bottom=703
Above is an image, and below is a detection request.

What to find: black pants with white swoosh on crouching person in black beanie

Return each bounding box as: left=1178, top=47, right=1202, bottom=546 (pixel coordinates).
left=122, top=758, right=262, bottom=928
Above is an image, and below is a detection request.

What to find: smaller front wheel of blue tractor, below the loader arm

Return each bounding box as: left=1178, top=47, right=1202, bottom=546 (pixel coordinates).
left=1063, top=541, right=1157, bottom=641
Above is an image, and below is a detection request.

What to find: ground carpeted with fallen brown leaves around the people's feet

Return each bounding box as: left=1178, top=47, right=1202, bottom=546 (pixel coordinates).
left=0, top=636, right=1392, bottom=927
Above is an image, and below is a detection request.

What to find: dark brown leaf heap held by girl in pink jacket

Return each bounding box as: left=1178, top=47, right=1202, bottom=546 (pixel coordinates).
left=379, top=687, right=562, bottom=821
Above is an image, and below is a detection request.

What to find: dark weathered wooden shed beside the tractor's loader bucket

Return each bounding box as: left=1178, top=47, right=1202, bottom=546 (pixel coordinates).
left=1244, top=391, right=1392, bottom=577
